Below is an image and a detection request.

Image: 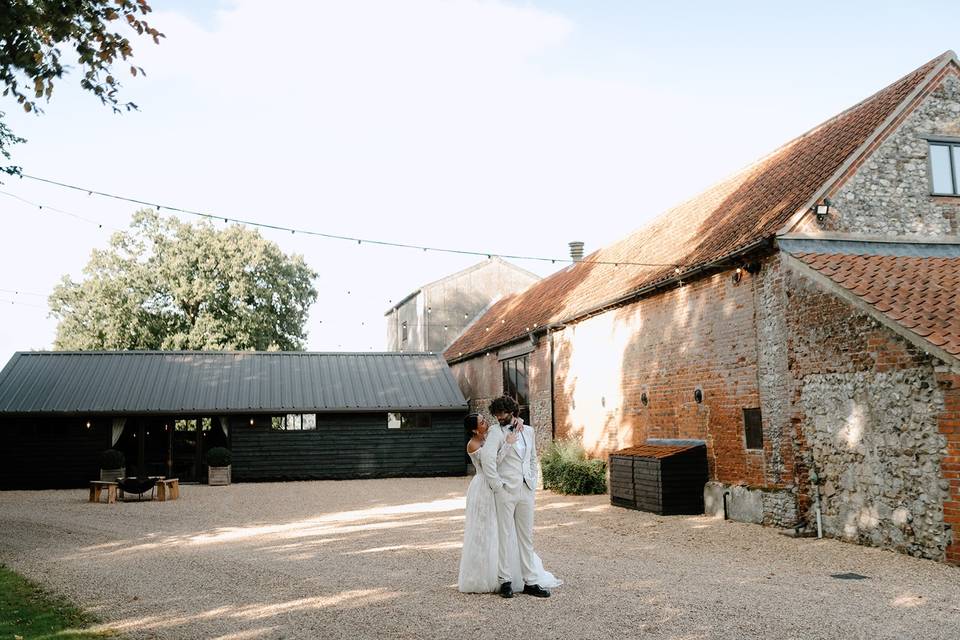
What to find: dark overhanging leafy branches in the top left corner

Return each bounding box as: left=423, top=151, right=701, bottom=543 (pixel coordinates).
left=0, top=0, right=164, bottom=175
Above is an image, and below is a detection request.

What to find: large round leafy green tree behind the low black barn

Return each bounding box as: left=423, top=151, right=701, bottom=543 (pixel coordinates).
left=50, top=209, right=317, bottom=351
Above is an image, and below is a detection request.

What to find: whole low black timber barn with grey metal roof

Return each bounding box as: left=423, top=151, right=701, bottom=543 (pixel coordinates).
left=0, top=351, right=467, bottom=489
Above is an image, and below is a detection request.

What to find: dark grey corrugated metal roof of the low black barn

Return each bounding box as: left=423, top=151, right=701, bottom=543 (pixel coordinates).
left=0, top=351, right=467, bottom=415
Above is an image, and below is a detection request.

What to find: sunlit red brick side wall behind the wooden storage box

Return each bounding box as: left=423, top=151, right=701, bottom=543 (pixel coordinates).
left=555, top=260, right=765, bottom=485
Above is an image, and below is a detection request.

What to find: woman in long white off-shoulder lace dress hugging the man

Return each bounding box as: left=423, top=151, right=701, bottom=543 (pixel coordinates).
left=457, top=413, right=563, bottom=593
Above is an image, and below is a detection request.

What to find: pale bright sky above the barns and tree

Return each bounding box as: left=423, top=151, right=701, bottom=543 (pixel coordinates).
left=0, top=0, right=960, bottom=362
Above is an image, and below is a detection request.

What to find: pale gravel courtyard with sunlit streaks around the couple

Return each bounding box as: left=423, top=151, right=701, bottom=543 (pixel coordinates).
left=0, top=478, right=960, bottom=640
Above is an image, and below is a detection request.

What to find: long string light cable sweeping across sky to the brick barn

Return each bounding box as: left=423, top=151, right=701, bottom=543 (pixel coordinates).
left=16, top=173, right=685, bottom=274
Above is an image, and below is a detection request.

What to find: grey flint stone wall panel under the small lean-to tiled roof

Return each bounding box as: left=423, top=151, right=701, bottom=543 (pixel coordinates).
left=800, top=367, right=952, bottom=560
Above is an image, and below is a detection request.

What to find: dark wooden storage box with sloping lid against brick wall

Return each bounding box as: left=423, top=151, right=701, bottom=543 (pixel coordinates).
left=609, top=442, right=708, bottom=515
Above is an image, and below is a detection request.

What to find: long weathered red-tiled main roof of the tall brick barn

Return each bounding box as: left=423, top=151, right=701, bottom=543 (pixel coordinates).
left=445, top=52, right=953, bottom=361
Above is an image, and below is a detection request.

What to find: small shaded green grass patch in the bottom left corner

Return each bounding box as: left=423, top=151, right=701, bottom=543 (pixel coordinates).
left=0, top=565, right=118, bottom=640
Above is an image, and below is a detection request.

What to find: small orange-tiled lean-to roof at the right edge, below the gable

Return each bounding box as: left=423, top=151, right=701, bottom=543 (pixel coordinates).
left=793, top=253, right=960, bottom=358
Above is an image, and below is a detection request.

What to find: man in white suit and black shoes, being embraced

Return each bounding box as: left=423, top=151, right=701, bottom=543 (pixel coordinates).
left=480, top=396, right=550, bottom=598
